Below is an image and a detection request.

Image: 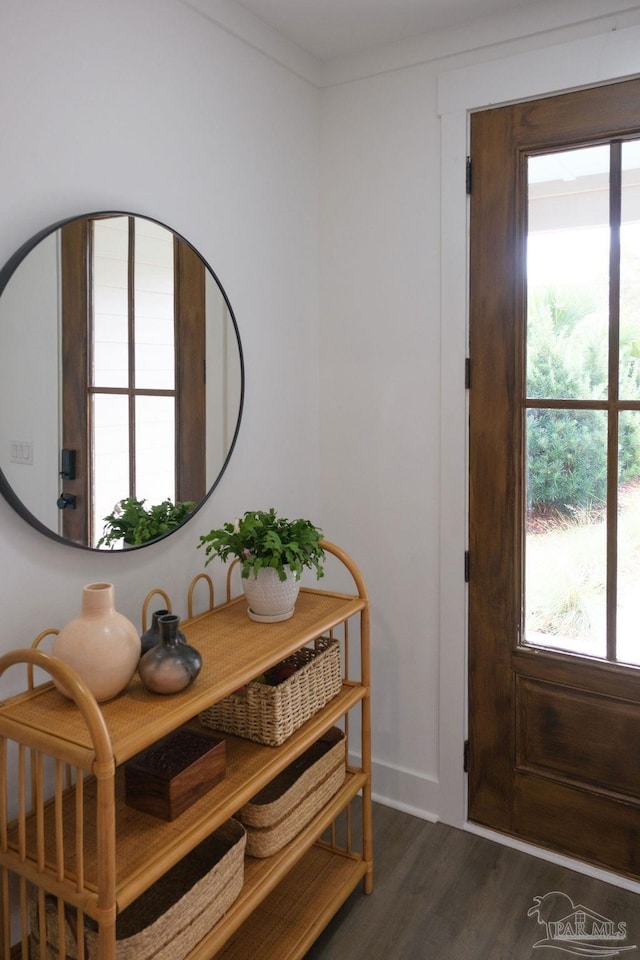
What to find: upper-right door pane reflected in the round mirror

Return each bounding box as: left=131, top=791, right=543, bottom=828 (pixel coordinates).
left=134, top=219, right=175, bottom=390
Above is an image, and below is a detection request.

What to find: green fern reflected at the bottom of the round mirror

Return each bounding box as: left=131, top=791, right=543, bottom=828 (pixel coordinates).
left=98, top=497, right=196, bottom=549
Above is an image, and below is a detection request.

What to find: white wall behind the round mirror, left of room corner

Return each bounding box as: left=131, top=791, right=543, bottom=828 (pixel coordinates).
left=0, top=0, right=319, bottom=688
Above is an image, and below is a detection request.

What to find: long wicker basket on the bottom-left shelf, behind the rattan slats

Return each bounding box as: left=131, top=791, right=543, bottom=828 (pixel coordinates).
left=29, top=820, right=246, bottom=960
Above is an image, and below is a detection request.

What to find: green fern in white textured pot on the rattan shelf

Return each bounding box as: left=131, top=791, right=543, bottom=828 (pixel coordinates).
left=198, top=507, right=324, bottom=621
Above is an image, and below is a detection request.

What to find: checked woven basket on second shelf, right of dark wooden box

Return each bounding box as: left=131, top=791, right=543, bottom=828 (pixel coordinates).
left=200, top=637, right=342, bottom=747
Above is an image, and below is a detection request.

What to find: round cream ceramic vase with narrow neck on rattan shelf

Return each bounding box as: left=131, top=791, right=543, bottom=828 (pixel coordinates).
left=52, top=583, right=140, bottom=701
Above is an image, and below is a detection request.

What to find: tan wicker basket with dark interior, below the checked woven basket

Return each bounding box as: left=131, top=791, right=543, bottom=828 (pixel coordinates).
left=238, top=727, right=346, bottom=857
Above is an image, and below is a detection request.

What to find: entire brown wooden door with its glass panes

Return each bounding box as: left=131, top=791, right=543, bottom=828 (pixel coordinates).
left=469, top=80, right=640, bottom=877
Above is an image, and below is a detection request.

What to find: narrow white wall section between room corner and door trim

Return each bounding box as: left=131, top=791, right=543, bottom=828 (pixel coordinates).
left=320, top=70, right=440, bottom=812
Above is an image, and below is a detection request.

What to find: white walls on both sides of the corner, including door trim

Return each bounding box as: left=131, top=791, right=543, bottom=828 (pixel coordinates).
left=0, top=0, right=640, bottom=856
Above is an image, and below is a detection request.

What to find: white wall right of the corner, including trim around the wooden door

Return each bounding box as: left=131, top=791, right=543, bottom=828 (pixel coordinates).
left=320, top=2, right=640, bottom=826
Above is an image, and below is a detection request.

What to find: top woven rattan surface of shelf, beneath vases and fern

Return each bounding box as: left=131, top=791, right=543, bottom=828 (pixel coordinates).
left=0, top=589, right=365, bottom=764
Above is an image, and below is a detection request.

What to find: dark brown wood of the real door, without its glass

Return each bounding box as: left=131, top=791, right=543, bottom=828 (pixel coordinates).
left=469, top=80, right=640, bottom=878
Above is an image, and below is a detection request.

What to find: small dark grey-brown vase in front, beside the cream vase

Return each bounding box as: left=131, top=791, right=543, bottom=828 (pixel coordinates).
left=138, top=613, right=202, bottom=693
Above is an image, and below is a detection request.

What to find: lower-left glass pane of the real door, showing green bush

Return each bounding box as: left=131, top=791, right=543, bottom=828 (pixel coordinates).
left=524, top=409, right=607, bottom=657
